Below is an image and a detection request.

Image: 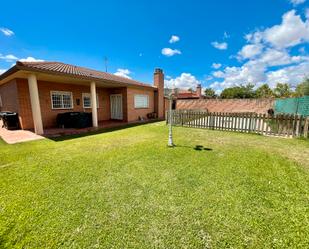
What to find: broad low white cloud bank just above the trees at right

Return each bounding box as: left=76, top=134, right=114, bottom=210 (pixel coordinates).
left=211, top=49, right=309, bottom=90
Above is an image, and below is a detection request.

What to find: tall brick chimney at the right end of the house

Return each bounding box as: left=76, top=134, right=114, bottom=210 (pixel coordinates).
left=153, top=68, right=164, bottom=119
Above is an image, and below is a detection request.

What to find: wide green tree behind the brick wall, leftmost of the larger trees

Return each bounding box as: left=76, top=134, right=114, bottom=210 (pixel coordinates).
left=220, top=84, right=255, bottom=99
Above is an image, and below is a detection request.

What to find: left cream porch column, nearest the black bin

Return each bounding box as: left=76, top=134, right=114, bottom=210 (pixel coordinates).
left=28, top=74, right=44, bottom=135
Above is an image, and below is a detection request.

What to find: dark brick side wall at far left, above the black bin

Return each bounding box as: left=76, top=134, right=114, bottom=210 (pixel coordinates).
left=0, top=80, right=19, bottom=112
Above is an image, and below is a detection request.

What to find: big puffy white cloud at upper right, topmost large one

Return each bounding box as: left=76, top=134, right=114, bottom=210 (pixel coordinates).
left=246, top=10, right=309, bottom=49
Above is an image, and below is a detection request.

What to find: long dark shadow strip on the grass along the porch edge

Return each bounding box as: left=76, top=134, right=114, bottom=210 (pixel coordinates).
left=46, top=120, right=162, bottom=142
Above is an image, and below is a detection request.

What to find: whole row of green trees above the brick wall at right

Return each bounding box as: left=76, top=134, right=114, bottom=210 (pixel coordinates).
left=204, top=78, right=309, bottom=99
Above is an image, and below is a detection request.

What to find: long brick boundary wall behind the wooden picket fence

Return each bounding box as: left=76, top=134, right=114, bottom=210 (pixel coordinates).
left=176, top=99, right=275, bottom=113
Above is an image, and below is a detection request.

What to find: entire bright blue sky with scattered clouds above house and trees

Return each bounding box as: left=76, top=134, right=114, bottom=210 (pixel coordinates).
left=0, top=0, right=309, bottom=91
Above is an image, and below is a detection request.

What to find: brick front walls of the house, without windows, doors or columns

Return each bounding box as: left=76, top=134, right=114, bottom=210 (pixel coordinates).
left=13, top=79, right=154, bottom=129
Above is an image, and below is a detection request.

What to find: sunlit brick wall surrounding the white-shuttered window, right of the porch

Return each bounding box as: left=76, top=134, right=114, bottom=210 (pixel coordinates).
left=127, top=88, right=155, bottom=122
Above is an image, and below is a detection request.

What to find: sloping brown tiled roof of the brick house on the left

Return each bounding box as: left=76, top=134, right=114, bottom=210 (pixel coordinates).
left=0, top=61, right=156, bottom=88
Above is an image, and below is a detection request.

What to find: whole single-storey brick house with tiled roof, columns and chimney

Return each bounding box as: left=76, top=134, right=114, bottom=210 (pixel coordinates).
left=0, top=62, right=164, bottom=134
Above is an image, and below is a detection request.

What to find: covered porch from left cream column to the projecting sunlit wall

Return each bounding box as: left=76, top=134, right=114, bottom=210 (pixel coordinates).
left=27, top=74, right=127, bottom=135
